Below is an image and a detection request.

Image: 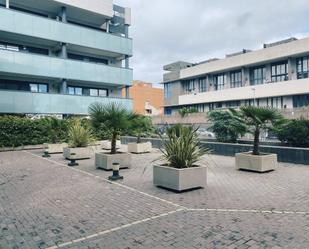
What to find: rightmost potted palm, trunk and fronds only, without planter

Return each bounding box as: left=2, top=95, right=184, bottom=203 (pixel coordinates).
left=231, top=106, right=283, bottom=155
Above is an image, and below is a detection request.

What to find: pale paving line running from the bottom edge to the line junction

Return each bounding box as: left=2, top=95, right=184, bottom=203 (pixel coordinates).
left=46, top=208, right=186, bottom=249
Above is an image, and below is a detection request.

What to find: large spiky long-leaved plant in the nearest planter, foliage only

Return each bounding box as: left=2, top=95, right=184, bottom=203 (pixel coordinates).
left=158, top=125, right=209, bottom=168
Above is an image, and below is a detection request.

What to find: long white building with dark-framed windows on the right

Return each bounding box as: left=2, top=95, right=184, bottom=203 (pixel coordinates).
left=163, top=38, right=309, bottom=115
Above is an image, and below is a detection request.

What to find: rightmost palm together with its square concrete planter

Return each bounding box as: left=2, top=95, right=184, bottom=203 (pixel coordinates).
left=231, top=106, right=283, bottom=172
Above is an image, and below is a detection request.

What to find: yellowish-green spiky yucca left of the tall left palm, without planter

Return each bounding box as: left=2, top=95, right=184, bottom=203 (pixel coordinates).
left=68, top=119, right=94, bottom=148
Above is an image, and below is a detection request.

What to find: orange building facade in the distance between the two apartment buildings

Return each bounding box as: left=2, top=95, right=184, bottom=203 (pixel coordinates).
left=123, top=80, right=164, bottom=116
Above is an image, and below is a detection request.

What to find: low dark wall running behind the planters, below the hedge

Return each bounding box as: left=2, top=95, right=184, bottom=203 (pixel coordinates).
left=121, top=137, right=309, bottom=165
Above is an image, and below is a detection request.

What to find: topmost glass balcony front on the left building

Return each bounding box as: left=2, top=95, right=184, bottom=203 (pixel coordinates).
left=0, top=7, right=132, bottom=57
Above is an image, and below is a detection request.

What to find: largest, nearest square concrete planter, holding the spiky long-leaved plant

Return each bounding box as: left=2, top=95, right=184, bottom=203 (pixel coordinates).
left=153, top=165, right=207, bottom=192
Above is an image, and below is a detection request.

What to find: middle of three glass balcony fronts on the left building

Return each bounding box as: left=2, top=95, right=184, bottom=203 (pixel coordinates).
left=0, top=50, right=133, bottom=85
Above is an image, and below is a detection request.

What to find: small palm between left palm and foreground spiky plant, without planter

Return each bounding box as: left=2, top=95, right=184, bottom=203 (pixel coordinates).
left=129, top=114, right=154, bottom=143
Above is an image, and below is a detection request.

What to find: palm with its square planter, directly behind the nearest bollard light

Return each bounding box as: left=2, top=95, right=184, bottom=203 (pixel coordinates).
left=89, top=102, right=132, bottom=170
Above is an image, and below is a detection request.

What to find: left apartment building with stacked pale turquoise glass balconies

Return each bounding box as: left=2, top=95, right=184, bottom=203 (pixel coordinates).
left=0, top=0, right=133, bottom=115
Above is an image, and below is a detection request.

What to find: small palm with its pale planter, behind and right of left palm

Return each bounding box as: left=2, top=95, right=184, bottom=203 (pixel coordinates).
left=128, top=114, right=153, bottom=154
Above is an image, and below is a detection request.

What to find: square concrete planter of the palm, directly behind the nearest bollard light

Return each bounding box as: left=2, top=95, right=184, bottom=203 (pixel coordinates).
left=95, top=152, right=131, bottom=170
